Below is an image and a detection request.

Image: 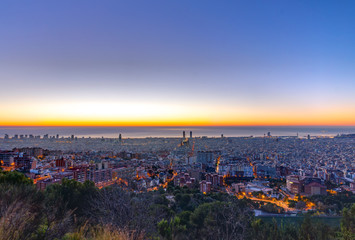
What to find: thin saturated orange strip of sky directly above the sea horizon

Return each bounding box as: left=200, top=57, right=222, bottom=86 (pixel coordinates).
left=0, top=112, right=355, bottom=127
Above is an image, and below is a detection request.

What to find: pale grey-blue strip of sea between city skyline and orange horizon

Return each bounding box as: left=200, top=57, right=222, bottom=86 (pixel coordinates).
left=0, top=126, right=355, bottom=138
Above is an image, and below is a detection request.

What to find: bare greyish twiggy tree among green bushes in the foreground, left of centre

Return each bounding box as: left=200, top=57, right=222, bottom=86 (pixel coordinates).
left=87, top=186, right=171, bottom=238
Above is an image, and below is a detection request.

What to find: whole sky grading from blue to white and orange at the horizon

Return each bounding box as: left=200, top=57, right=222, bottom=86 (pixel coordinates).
left=0, top=0, right=355, bottom=126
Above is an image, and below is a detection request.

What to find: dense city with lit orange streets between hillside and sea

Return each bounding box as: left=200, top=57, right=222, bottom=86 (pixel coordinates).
left=0, top=131, right=355, bottom=201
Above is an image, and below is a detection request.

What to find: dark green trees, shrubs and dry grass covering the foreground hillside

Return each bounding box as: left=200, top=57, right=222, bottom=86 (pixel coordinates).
left=0, top=171, right=355, bottom=240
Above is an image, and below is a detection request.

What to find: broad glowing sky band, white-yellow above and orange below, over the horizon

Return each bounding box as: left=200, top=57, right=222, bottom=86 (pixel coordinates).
left=0, top=102, right=355, bottom=127
